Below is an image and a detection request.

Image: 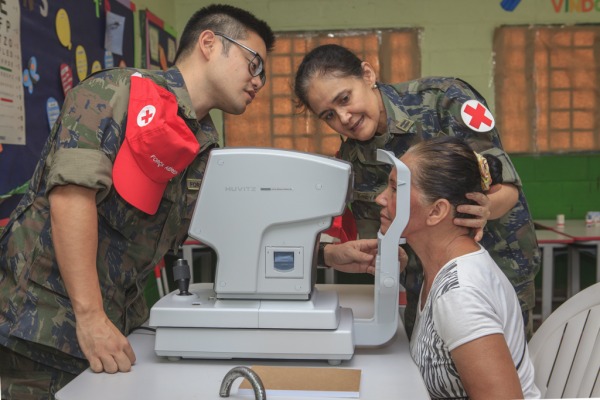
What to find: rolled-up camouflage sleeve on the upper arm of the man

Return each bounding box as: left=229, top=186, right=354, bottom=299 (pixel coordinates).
left=46, top=70, right=131, bottom=202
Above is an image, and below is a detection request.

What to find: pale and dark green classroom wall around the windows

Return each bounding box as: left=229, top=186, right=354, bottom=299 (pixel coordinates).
left=171, top=0, right=600, bottom=218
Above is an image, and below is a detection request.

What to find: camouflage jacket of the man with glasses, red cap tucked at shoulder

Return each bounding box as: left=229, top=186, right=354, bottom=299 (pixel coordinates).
left=0, top=68, right=217, bottom=368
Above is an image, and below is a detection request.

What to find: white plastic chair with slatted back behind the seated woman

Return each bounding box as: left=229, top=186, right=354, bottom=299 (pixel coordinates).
left=529, top=283, right=600, bottom=398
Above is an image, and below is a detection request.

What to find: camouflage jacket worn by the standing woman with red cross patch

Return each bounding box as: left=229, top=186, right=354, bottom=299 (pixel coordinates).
left=339, top=77, right=540, bottom=310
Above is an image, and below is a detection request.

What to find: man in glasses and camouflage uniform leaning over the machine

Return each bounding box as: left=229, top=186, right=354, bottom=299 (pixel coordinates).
left=0, top=5, right=274, bottom=399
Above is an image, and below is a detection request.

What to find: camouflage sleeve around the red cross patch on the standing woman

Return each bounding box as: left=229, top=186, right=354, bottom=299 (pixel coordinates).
left=441, top=80, right=521, bottom=187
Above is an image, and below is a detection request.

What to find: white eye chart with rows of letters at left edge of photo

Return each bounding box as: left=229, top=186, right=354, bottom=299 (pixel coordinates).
left=0, top=0, right=25, bottom=145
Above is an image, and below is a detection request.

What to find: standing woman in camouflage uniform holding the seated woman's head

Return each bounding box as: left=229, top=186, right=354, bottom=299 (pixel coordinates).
left=294, top=44, right=540, bottom=337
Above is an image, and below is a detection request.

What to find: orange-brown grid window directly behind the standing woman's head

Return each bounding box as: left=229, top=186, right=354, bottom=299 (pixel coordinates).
left=224, top=29, right=421, bottom=156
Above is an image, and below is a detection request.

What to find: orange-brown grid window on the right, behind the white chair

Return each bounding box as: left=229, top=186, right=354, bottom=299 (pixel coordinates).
left=494, top=25, right=600, bottom=153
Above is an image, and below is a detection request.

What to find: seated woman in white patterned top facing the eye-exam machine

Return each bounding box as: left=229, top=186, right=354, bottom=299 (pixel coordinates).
left=376, top=137, right=540, bottom=399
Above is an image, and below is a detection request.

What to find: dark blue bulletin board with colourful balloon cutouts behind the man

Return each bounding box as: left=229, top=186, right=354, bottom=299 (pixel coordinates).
left=0, top=0, right=135, bottom=219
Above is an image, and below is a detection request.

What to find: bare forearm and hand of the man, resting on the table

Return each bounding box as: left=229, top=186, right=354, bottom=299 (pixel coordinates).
left=49, top=185, right=135, bottom=373
